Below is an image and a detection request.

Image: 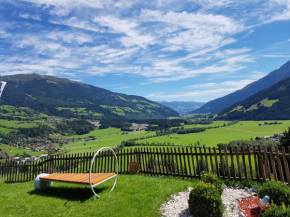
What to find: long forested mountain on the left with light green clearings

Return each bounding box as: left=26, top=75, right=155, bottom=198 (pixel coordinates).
left=1, top=74, right=179, bottom=119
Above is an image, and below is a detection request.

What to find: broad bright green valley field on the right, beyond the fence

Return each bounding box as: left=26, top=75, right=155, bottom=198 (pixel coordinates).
left=137, top=120, right=290, bottom=147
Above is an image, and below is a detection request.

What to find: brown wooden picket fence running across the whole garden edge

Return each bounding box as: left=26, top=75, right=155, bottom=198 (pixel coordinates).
left=0, top=147, right=290, bottom=185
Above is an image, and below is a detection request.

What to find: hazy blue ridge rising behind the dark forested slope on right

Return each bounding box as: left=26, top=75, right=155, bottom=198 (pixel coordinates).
left=191, top=61, right=290, bottom=114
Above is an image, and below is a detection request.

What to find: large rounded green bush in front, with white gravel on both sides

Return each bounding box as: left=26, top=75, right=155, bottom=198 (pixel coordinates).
left=188, top=182, right=224, bottom=217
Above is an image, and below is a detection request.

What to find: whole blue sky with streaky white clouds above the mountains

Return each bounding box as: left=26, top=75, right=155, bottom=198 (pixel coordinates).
left=0, top=0, right=290, bottom=102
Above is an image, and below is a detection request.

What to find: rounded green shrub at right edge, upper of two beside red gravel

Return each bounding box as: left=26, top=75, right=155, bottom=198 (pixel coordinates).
left=259, top=181, right=290, bottom=206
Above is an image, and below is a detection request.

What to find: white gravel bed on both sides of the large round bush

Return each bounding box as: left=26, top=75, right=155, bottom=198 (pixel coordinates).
left=160, top=186, right=257, bottom=217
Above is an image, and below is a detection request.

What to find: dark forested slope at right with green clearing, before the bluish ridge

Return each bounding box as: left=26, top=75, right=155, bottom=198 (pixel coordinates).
left=218, top=77, right=290, bottom=120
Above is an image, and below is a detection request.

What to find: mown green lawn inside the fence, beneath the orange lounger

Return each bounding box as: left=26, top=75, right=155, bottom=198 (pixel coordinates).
left=0, top=175, right=195, bottom=217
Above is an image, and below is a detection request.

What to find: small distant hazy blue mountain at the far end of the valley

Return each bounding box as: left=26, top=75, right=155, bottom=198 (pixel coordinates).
left=157, top=101, right=204, bottom=115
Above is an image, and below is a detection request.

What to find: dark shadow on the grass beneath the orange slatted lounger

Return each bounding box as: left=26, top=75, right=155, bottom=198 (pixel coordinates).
left=27, top=187, right=107, bottom=203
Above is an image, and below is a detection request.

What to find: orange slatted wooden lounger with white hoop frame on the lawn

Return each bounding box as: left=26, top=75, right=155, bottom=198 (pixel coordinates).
left=34, top=147, right=118, bottom=200
